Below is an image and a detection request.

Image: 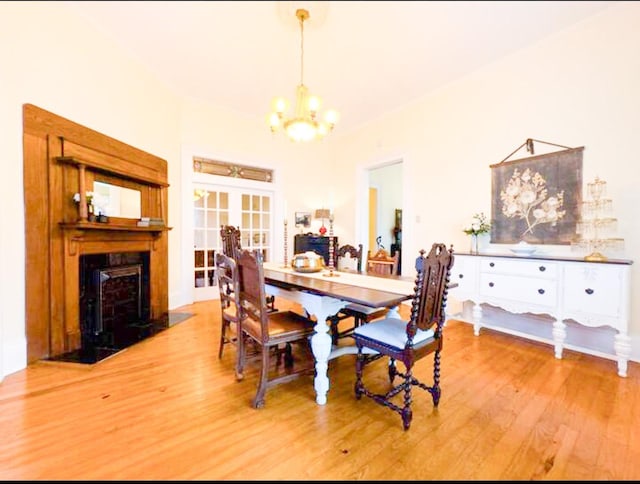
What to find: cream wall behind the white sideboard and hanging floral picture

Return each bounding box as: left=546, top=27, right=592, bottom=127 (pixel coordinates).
left=332, top=2, right=640, bottom=359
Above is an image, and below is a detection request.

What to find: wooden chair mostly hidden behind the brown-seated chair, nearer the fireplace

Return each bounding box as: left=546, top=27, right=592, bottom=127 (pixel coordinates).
left=215, top=252, right=241, bottom=370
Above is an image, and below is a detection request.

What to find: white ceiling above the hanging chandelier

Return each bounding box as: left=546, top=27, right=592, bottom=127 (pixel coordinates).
left=58, top=1, right=616, bottom=132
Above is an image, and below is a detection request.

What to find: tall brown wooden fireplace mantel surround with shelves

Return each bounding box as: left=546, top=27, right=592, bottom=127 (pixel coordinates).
left=23, top=104, right=170, bottom=363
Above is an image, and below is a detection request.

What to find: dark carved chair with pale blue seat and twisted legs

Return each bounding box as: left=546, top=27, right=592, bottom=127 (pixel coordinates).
left=353, top=243, right=454, bottom=430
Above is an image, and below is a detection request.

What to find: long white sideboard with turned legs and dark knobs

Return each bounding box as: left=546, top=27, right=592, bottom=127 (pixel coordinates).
left=449, top=253, right=632, bottom=377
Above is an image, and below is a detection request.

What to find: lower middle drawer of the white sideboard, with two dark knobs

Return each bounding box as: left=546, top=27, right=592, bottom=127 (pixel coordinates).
left=480, top=273, right=558, bottom=307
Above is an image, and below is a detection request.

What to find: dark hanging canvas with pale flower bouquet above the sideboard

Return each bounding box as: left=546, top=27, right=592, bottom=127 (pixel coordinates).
left=490, top=146, right=584, bottom=245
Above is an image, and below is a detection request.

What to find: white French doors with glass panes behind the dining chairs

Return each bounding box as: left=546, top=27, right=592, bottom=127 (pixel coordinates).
left=193, top=183, right=273, bottom=301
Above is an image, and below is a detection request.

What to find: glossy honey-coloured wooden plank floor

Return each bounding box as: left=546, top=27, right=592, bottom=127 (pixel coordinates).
left=0, top=301, right=640, bottom=480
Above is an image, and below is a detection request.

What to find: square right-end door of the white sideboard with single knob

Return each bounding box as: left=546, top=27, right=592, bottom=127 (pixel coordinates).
left=563, top=264, right=623, bottom=317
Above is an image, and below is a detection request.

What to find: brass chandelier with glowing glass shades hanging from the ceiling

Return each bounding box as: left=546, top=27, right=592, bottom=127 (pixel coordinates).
left=269, top=8, right=338, bottom=141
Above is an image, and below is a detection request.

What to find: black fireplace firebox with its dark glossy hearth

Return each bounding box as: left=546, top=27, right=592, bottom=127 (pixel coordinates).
left=51, top=252, right=169, bottom=363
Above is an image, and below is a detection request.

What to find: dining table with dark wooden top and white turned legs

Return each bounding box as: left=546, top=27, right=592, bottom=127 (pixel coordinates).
left=263, top=262, right=415, bottom=405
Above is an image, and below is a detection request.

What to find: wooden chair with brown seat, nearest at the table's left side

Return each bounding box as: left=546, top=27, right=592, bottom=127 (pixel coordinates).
left=236, top=250, right=315, bottom=408
